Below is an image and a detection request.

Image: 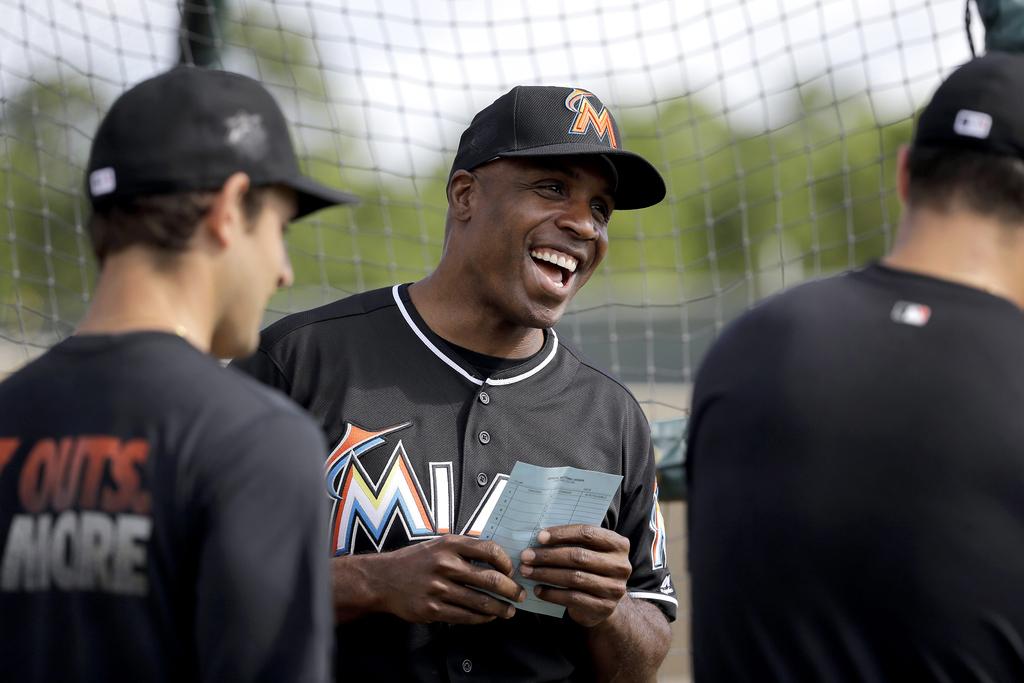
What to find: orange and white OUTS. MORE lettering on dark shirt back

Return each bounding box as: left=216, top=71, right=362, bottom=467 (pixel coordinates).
left=0, top=434, right=153, bottom=596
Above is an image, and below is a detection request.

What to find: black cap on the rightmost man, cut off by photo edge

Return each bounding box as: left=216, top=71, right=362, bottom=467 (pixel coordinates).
left=913, top=52, right=1024, bottom=159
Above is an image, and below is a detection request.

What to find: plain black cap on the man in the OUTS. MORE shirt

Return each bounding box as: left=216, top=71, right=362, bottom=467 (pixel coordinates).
left=86, top=67, right=357, bottom=218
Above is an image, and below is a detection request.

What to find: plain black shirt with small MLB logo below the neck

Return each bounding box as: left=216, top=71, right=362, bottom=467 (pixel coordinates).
left=687, top=265, right=1024, bottom=683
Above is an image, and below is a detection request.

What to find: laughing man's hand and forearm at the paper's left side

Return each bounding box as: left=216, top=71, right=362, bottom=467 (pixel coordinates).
left=335, top=536, right=526, bottom=624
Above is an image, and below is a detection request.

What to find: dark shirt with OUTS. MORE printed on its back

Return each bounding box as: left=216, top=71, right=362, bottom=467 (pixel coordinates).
left=0, top=332, right=333, bottom=683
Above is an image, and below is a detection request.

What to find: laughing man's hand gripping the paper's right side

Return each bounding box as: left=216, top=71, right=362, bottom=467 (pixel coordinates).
left=519, top=524, right=633, bottom=627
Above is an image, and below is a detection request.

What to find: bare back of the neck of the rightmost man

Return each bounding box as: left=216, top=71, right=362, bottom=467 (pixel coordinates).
left=883, top=209, right=1024, bottom=308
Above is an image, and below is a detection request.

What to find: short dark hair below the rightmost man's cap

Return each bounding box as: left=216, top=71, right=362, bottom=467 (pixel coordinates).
left=907, top=146, right=1024, bottom=224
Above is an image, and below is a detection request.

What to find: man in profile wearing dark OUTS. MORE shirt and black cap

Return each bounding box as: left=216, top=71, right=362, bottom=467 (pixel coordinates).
left=0, top=68, right=350, bottom=682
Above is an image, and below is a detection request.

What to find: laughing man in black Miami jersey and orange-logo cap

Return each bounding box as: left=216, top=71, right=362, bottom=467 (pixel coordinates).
left=235, top=87, right=676, bottom=681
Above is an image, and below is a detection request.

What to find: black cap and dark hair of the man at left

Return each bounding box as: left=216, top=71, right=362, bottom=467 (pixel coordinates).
left=80, top=67, right=354, bottom=262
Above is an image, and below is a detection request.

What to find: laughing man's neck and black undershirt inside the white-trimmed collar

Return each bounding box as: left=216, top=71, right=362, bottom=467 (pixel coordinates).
left=409, top=271, right=544, bottom=358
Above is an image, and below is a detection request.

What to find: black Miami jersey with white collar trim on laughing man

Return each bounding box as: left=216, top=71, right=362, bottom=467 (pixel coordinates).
left=234, top=286, right=677, bottom=681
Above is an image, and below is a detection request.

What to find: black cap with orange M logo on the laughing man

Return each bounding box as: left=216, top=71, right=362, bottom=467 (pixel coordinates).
left=449, top=85, right=665, bottom=209
